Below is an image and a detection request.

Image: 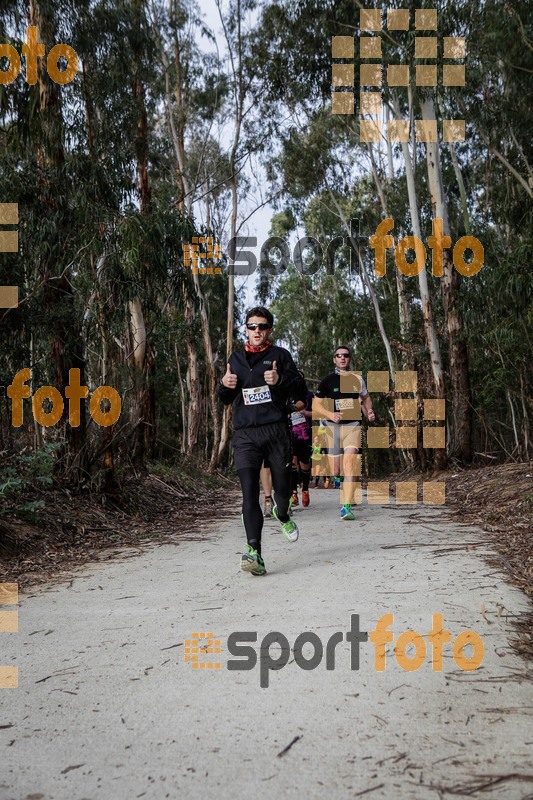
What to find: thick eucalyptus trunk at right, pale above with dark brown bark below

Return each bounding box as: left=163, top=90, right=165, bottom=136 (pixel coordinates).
left=421, top=96, right=473, bottom=462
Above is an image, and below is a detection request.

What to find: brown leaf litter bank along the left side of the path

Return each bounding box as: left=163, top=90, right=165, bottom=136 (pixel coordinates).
left=0, top=471, right=237, bottom=589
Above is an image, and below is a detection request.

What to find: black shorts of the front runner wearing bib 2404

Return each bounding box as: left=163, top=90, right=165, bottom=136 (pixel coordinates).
left=233, top=422, right=292, bottom=471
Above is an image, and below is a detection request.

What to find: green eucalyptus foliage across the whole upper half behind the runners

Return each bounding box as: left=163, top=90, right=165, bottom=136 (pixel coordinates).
left=0, top=0, right=533, bottom=484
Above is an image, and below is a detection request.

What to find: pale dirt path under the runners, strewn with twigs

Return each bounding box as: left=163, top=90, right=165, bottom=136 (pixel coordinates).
left=0, top=491, right=533, bottom=800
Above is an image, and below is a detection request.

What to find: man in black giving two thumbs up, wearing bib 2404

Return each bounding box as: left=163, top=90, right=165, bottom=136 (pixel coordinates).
left=218, top=306, right=307, bottom=575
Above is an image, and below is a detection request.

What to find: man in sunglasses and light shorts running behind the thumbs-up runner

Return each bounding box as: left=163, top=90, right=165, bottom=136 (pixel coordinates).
left=313, top=345, right=376, bottom=520
